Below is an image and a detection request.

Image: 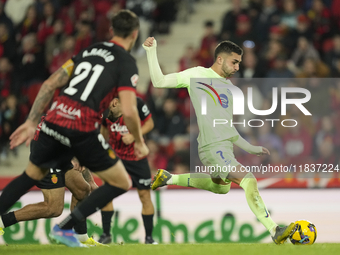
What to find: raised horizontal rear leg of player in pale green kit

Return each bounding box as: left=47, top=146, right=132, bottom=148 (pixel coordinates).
left=151, top=169, right=231, bottom=194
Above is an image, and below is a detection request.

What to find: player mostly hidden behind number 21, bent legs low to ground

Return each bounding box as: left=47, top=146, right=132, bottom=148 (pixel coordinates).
left=0, top=116, right=103, bottom=247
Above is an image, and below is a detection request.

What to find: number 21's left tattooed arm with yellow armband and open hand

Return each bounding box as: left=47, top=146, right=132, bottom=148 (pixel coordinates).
left=10, top=60, right=74, bottom=149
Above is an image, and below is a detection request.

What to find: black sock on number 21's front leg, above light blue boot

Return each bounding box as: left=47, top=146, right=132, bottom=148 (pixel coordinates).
left=59, top=183, right=126, bottom=229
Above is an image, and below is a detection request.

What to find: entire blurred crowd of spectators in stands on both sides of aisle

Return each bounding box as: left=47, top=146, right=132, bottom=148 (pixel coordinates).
left=0, top=0, right=340, bottom=177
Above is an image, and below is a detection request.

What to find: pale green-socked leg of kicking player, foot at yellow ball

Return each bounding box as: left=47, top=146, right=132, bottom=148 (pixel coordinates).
left=227, top=165, right=296, bottom=244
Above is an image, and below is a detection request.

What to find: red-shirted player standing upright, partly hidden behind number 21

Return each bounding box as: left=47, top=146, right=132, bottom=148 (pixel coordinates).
left=98, top=97, right=157, bottom=244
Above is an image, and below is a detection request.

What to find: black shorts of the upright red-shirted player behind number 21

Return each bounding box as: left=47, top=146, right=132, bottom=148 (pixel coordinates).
left=122, top=158, right=151, bottom=189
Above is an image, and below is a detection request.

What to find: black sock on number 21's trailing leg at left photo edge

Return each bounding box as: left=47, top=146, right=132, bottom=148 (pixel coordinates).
left=0, top=172, right=39, bottom=215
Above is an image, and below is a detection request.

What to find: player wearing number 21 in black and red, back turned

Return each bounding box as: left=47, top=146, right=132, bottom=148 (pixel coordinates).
left=0, top=10, right=149, bottom=247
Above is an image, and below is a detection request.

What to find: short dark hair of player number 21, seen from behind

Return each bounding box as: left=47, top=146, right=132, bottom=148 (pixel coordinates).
left=111, top=10, right=139, bottom=38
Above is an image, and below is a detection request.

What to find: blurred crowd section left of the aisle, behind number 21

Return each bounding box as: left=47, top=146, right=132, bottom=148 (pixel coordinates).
left=0, top=0, right=181, bottom=164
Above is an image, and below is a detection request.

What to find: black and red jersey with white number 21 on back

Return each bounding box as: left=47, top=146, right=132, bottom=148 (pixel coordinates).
left=46, top=41, right=138, bottom=132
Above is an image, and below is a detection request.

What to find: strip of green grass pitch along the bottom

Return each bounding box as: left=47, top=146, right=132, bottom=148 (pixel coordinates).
left=0, top=243, right=340, bottom=255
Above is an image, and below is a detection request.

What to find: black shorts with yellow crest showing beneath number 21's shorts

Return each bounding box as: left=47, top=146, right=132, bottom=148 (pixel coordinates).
left=36, top=168, right=73, bottom=189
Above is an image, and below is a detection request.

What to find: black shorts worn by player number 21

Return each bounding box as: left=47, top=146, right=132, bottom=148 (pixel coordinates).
left=30, top=122, right=119, bottom=172
